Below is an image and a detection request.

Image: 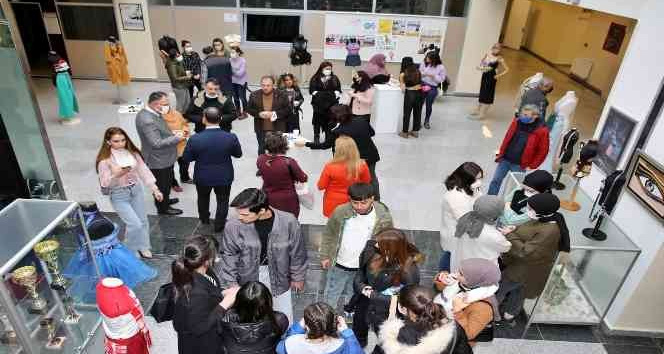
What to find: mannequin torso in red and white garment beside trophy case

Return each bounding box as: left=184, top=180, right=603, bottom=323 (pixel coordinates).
left=97, top=278, right=152, bottom=354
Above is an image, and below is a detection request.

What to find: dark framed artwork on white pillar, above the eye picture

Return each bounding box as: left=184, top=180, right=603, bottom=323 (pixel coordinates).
left=593, top=107, right=636, bottom=175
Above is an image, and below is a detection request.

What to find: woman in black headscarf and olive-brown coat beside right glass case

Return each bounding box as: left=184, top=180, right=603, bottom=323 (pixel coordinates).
left=496, top=193, right=570, bottom=322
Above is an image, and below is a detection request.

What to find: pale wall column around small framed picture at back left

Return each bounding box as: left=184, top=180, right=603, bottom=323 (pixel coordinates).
left=113, top=0, right=157, bottom=79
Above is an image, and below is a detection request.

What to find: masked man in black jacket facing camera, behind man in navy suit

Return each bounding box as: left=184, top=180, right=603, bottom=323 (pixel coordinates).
left=185, top=77, right=237, bottom=133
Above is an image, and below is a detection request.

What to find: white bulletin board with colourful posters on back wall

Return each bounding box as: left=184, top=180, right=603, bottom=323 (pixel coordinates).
left=323, top=14, right=447, bottom=62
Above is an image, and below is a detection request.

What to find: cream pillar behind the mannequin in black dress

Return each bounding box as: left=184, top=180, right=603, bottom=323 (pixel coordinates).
left=455, top=0, right=507, bottom=94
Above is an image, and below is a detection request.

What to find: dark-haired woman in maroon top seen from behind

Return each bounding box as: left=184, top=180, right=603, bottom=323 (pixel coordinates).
left=256, top=132, right=308, bottom=218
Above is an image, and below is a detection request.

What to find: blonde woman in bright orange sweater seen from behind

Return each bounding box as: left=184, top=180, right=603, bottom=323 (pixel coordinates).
left=318, top=136, right=371, bottom=218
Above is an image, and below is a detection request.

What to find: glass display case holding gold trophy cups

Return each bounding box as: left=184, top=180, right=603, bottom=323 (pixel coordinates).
left=0, top=199, right=101, bottom=354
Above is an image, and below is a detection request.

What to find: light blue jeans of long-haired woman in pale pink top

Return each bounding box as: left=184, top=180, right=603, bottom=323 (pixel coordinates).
left=110, top=184, right=151, bottom=251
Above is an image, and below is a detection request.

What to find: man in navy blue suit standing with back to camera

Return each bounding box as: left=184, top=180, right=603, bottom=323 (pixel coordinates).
left=182, top=107, right=242, bottom=232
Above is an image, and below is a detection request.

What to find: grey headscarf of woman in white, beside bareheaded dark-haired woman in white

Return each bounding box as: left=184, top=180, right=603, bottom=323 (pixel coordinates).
left=454, top=195, right=504, bottom=238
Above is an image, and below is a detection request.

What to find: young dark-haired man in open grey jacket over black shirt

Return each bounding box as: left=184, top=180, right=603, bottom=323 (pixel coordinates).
left=217, top=188, right=307, bottom=323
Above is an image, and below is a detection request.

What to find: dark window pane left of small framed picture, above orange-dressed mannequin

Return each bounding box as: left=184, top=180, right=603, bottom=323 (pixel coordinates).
left=58, top=5, right=118, bottom=41
